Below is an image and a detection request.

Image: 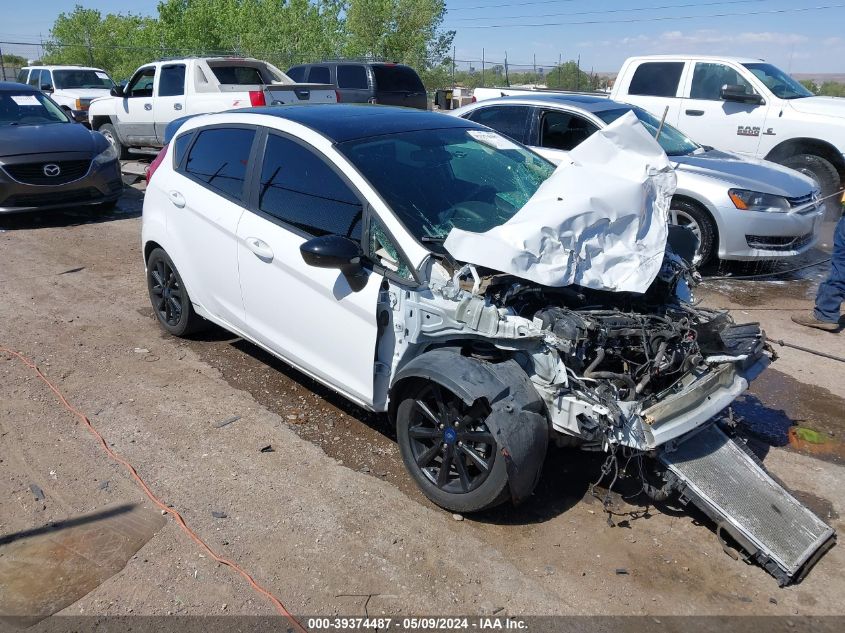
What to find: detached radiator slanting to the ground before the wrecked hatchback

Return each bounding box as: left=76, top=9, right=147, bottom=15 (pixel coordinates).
left=660, top=425, right=836, bottom=587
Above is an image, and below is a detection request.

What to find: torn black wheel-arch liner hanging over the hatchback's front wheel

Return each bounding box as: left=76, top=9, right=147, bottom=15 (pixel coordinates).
left=390, top=348, right=549, bottom=504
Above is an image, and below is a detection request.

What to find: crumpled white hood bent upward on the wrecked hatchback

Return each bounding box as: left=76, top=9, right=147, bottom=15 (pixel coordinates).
left=444, top=112, right=676, bottom=292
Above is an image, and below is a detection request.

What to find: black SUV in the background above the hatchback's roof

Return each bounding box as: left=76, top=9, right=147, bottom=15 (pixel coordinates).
left=287, top=61, right=428, bottom=110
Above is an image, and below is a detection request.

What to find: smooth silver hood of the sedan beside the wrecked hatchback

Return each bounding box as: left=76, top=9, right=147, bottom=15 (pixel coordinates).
left=669, top=150, right=816, bottom=198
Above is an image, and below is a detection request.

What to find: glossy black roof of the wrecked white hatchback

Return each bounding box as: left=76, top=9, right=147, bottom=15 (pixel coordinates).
left=234, top=103, right=486, bottom=143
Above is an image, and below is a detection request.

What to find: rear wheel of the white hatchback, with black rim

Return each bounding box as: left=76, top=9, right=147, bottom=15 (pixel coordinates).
left=147, top=248, right=203, bottom=336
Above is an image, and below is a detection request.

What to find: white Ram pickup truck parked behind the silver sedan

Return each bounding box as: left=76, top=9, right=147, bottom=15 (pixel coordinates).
left=610, top=55, right=845, bottom=200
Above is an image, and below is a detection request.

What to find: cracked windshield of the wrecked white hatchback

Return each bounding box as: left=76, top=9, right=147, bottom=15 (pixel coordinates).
left=338, top=128, right=555, bottom=250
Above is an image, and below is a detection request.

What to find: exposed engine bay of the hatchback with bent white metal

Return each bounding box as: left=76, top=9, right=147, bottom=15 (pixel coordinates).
left=391, top=239, right=771, bottom=450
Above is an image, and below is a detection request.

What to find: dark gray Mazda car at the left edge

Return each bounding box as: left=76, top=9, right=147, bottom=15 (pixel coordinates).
left=0, top=82, right=123, bottom=213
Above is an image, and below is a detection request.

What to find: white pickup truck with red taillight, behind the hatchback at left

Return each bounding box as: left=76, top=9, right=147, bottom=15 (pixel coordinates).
left=88, top=57, right=337, bottom=158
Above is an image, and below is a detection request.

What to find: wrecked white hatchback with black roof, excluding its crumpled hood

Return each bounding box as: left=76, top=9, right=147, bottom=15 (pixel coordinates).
left=143, top=104, right=769, bottom=512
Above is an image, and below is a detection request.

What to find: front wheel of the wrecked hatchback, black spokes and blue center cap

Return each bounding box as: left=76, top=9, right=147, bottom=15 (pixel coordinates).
left=396, top=380, right=510, bottom=512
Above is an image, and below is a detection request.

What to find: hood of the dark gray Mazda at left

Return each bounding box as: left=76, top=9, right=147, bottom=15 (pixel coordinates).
left=0, top=123, right=96, bottom=157
